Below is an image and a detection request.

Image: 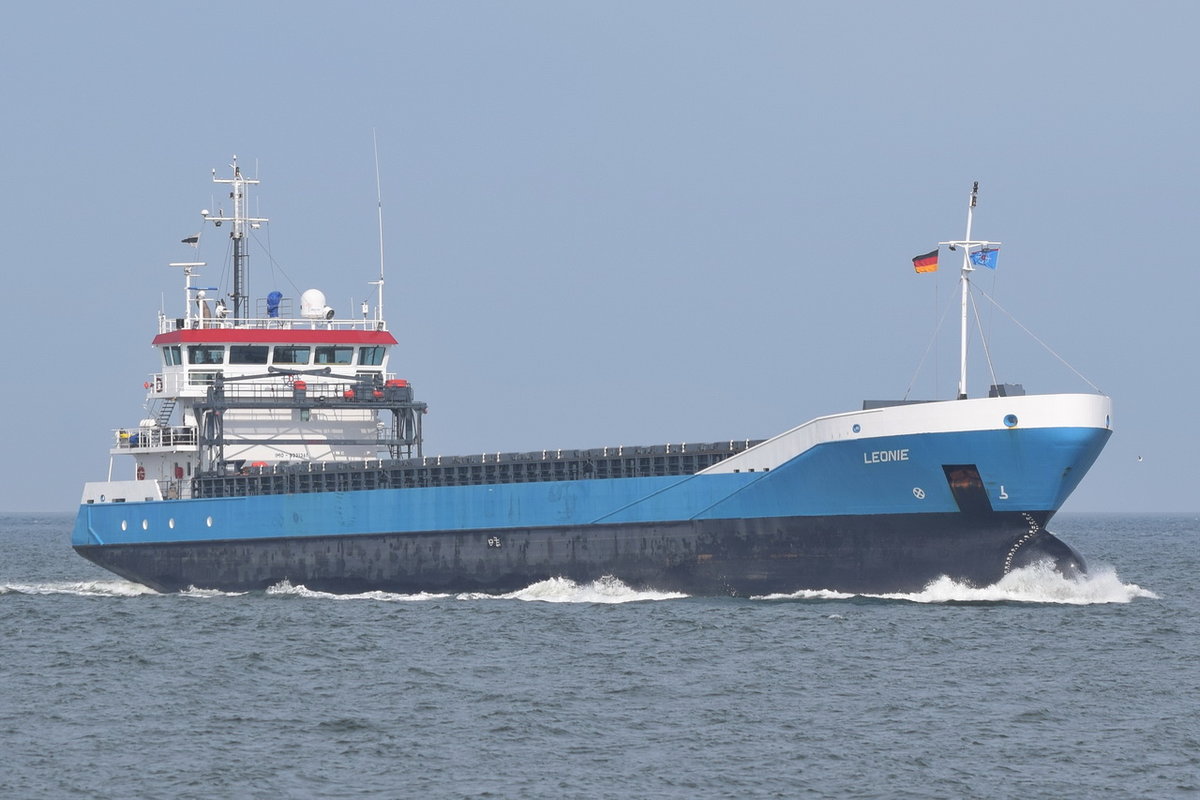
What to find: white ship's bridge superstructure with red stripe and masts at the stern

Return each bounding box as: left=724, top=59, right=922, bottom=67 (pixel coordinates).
left=97, top=157, right=425, bottom=497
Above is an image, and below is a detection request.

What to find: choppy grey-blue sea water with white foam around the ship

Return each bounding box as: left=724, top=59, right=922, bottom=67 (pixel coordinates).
left=0, top=515, right=1200, bottom=799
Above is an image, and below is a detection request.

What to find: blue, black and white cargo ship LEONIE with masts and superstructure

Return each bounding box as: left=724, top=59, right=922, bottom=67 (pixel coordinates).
left=72, top=164, right=1112, bottom=596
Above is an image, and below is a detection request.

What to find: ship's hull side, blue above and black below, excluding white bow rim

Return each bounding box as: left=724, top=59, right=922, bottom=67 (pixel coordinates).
left=72, top=427, right=1110, bottom=595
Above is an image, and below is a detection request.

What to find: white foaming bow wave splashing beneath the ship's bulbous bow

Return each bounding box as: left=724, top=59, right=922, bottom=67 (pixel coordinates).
left=760, top=561, right=1158, bottom=606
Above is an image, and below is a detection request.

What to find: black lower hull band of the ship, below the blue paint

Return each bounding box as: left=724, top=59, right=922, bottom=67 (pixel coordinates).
left=76, top=513, right=1086, bottom=596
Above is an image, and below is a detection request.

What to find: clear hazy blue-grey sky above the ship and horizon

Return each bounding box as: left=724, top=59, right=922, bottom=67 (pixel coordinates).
left=0, top=0, right=1200, bottom=511
